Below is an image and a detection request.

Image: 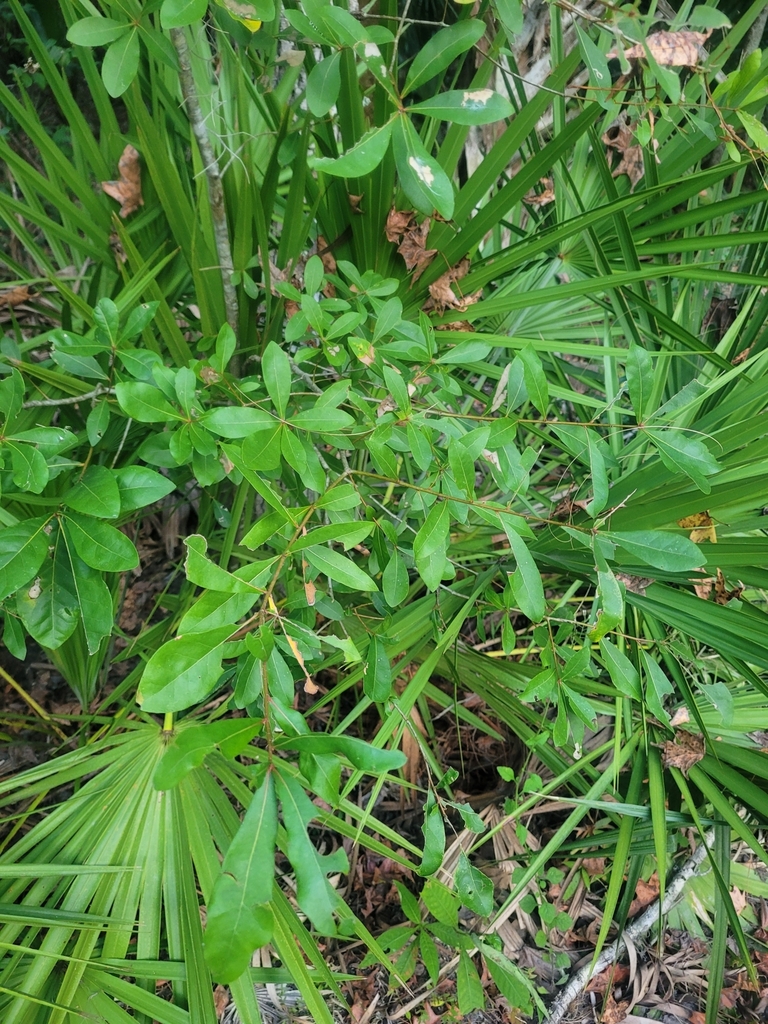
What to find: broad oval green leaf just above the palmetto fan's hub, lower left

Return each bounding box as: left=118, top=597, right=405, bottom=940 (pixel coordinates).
left=136, top=626, right=233, bottom=713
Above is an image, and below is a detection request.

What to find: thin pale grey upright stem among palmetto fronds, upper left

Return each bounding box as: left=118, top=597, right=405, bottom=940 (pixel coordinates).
left=170, top=29, right=238, bottom=348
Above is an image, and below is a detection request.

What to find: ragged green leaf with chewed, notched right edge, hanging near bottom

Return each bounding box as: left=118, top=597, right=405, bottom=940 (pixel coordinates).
left=275, top=774, right=348, bottom=935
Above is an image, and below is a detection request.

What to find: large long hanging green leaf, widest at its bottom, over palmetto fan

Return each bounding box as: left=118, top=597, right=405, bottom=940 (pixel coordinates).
left=205, top=772, right=278, bottom=984
